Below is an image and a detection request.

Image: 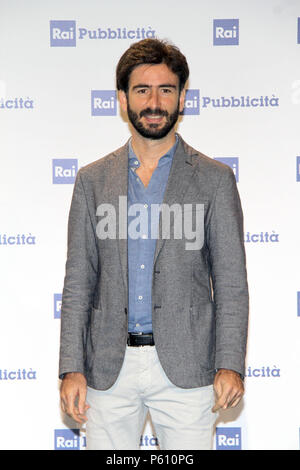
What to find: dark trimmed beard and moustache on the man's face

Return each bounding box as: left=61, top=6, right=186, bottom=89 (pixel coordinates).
left=127, top=100, right=180, bottom=140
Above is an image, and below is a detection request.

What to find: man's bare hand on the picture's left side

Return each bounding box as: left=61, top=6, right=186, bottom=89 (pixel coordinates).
left=60, top=372, right=90, bottom=423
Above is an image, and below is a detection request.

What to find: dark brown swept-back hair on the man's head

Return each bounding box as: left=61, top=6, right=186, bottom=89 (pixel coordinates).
left=116, top=39, right=189, bottom=93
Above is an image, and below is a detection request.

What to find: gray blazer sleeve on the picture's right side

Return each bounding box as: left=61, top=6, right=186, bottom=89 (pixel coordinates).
left=207, top=167, right=249, bottom=376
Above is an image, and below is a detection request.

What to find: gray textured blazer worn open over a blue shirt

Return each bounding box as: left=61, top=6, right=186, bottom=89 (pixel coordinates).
left=59, top=136, right=249, bottom=390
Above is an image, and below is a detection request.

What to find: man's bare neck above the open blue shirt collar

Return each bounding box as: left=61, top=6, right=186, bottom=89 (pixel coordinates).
left=131, top=130, right=176, bottom=167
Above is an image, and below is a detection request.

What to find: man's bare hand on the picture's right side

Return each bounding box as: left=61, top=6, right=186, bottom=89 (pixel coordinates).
left=212, top=369, right=244, bottom=413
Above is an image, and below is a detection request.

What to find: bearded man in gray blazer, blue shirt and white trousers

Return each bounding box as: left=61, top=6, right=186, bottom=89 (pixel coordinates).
left=59, top=39, right=248, bottom=449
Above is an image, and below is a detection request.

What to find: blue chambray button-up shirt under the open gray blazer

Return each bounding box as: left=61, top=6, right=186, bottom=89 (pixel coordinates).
left=127, top=135, right=178, bottom=333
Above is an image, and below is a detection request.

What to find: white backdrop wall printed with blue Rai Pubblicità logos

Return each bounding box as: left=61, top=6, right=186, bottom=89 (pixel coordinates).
left=0, top=0, right=300, bottom=450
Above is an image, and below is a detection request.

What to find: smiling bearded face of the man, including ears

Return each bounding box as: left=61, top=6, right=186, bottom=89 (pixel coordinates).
left=120, top=64, right=184, bottom=139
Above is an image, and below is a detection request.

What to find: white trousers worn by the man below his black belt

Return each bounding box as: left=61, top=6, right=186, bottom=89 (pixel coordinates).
left=86, top=346, right=217, bottom=450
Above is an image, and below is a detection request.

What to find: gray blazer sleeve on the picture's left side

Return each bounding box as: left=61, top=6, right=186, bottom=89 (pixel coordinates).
left=59, top=170, right=98, bottom=377
